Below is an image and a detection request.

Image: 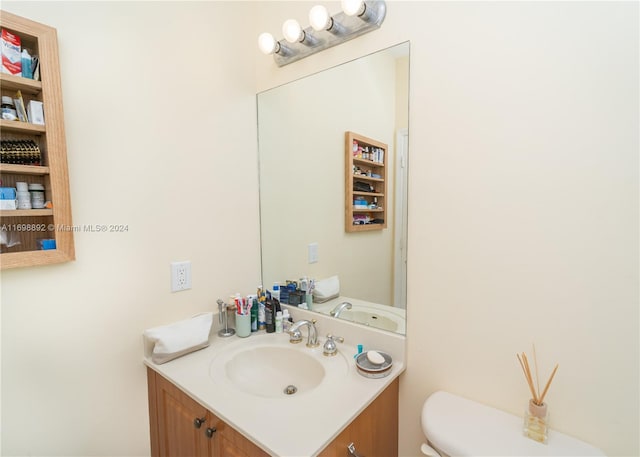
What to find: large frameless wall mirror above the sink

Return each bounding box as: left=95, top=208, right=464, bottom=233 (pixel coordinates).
left=258, top=42, right=409, bottom=334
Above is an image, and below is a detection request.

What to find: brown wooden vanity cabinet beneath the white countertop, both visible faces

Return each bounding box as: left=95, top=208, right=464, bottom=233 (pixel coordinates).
left=147, top=368, right=398, bottom=457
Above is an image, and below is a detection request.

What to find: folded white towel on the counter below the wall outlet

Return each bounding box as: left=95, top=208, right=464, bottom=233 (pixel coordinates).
left=143, top=312, right=213, bottom=365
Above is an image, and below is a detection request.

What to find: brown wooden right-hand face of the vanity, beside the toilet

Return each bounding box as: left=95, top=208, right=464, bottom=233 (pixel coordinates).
left=320, top=379, right=399, bottom=457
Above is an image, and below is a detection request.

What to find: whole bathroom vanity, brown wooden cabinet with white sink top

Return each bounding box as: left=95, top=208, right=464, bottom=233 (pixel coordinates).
left=144, top=312, right=405, bottom=457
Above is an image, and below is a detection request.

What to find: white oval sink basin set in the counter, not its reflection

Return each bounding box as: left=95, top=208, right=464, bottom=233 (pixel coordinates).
left=209, top=335, right=347, bottom=398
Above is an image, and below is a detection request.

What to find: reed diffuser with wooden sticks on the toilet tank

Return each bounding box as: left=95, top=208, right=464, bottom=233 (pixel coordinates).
left=516, top=346, right=558, bottom=444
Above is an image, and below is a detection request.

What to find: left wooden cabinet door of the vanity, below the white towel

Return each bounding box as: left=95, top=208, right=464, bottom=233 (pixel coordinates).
left=147, top=369, right=217, bottom=457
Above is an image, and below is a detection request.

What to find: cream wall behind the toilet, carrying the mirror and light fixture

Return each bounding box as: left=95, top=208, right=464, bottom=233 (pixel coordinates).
left=256, top=1, right=640, bottom=456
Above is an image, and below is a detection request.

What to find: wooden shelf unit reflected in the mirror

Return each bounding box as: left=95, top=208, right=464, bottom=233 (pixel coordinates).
left=344, top=132, right=389, bottom=232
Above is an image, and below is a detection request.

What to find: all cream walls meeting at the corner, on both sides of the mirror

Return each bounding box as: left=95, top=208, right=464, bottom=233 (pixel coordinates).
left=2, top=1, right=640, bottom=456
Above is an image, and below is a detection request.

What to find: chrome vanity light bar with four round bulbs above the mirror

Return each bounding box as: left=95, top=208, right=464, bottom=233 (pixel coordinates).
left=258, top=0, right=387, bottom=67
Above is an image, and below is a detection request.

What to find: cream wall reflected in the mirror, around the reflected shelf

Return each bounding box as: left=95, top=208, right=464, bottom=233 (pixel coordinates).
left=258, top=52, right=398, bottom=305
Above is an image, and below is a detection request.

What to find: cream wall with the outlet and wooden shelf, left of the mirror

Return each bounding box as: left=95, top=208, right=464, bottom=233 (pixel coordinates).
left=2, top=1, right=260, bottom=456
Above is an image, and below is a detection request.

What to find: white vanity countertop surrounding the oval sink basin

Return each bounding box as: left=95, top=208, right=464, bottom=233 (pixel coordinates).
left=144, top=321, right=404, bottom=457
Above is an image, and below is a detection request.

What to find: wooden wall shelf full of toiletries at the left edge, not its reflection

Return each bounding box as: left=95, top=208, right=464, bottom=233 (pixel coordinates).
left=0, top=11, right=75, bottom=269
